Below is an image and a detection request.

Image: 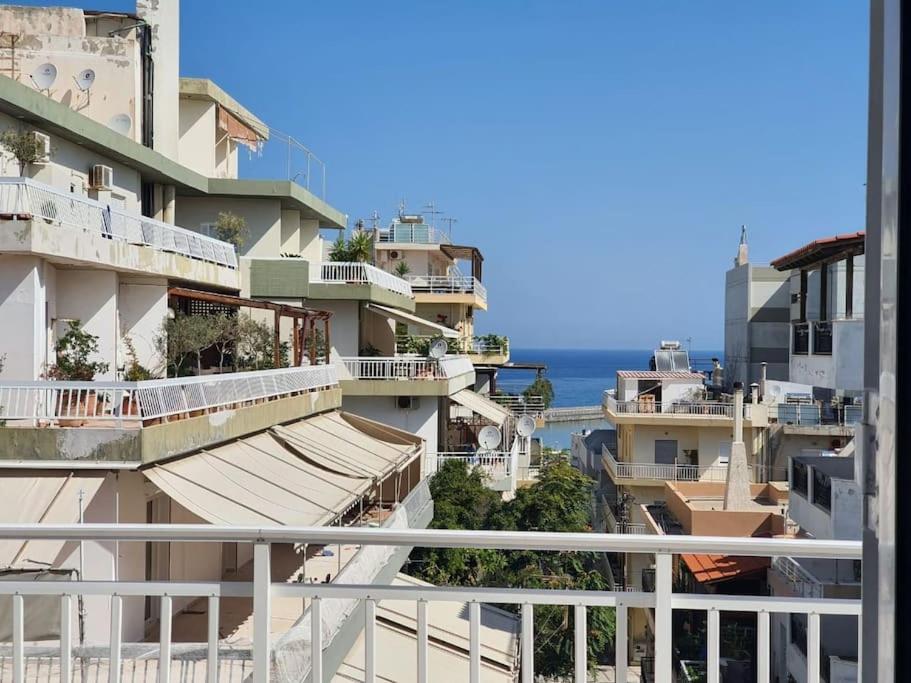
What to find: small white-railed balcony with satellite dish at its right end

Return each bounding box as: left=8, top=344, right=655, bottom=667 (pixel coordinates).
left=340, top=356, right=474, bottom=396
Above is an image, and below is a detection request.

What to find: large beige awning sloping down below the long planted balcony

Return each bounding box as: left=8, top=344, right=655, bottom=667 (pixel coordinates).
left=143, top=413, right=420, bottom=526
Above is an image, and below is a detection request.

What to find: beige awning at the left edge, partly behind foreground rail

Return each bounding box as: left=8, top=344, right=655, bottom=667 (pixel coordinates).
left=0, top=470, right=107, bottom=569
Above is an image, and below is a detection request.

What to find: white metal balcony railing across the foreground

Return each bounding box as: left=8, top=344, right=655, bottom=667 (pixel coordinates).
left=0, top=524, right=862, bottom=683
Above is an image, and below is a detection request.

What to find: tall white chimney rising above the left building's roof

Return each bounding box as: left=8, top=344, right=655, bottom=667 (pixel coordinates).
left=136, top=0, right=180, bottom=161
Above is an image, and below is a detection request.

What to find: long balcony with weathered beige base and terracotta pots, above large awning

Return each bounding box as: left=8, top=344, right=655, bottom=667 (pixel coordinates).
left=0, top=365, right=341, bottom=462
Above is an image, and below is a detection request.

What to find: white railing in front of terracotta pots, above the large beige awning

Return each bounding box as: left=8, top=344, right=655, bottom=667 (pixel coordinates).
left=0, top=365, right=338, bottom=426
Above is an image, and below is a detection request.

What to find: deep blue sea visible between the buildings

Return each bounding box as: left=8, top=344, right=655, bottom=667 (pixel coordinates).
left=497, top=348, right=722, bottom=449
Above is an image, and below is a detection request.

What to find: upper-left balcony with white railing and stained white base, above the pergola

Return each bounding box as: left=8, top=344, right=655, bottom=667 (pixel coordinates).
left=0, top=178, right=237, bottom=287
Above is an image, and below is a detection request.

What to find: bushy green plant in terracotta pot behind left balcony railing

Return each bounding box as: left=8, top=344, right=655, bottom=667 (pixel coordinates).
left=45, top=320, right=110, bottom=427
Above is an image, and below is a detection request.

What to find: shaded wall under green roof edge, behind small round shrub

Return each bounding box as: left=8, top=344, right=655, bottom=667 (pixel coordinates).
left=176, top=197, right=282, bottom=258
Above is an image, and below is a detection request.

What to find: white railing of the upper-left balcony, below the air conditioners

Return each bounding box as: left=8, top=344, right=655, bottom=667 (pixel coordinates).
left=0, top=178, right=237, bottom=268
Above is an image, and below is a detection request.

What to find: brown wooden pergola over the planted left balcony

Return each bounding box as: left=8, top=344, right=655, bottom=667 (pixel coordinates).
left=168, top=287, right=332, bottom=367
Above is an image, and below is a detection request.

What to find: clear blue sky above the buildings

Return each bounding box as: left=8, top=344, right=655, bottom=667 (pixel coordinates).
left=23, top=0, right=868, bottom=348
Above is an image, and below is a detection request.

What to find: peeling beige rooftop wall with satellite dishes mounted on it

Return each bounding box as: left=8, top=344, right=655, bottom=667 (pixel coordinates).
left=0, top=5, right=142, bottom=141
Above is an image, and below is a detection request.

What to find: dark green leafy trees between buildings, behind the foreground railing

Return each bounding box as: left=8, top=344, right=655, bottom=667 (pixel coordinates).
left=408, top=456, right=615, bottom=679
